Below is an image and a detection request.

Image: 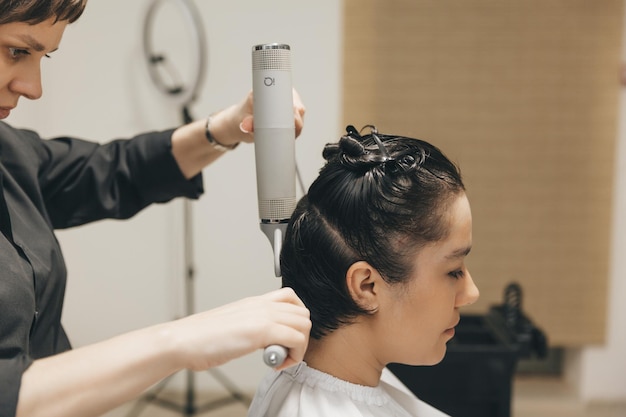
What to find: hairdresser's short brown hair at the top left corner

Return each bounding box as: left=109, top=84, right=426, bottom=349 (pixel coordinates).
left=0, top=0, right=87, bottom=25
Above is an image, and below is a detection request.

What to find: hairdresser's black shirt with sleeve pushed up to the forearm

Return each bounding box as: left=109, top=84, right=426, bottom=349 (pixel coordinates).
left=0, top=122, right=203, bottom=417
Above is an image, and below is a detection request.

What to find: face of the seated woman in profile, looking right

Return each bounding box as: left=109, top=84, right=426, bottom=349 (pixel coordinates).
left=370, top=194, right=478, bottom=365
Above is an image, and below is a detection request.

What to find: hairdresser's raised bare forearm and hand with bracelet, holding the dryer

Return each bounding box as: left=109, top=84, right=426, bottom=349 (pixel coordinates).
left=172, top=90, right=305, bottom=178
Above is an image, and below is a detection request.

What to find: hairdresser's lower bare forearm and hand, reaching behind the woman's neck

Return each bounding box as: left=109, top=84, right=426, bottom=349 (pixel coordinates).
left=17, top=289, right=311, bottom=417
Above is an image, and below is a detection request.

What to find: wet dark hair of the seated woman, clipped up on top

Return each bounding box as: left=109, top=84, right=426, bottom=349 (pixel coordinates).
left=281, top=126, right=465, bottom=339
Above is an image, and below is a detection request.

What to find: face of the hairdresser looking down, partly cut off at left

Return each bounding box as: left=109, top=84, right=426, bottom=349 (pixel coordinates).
left=0, top=19, right=67, bottom=120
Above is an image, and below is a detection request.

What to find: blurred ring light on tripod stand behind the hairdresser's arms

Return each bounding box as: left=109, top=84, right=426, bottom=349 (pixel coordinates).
left=127, top=0, right=251, bottom=417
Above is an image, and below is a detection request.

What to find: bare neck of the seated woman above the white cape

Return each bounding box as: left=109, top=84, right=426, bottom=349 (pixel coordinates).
left=304, top=324, right=386, bottom=387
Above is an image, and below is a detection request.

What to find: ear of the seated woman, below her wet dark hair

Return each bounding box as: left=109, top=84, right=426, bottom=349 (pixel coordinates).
left=346, top=261, right=382, bottom=312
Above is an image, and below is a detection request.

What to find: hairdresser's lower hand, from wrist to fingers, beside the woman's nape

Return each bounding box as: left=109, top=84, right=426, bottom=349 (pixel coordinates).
left=167, top=288, right=311, bottom=371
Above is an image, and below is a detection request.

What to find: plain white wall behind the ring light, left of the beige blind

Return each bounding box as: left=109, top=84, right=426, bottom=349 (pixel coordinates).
left=8, top=0, right=341, bottom=390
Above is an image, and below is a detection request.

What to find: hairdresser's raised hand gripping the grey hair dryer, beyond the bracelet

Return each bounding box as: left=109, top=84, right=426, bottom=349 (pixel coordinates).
left=211, top=89, right=306, bottom=145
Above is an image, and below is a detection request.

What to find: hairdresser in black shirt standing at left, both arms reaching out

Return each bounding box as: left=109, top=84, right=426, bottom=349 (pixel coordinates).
left=0, top=0, right=311, bottom=417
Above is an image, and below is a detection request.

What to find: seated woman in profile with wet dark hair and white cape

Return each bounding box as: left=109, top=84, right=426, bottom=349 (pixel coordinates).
left=248, top=126, right=478, bottom=417
